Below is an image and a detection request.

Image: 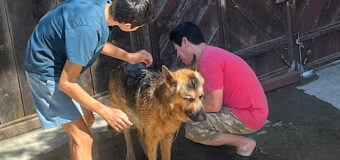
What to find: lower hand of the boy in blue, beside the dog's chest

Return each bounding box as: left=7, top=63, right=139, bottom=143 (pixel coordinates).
left=101, top=107, right=132, bottom=132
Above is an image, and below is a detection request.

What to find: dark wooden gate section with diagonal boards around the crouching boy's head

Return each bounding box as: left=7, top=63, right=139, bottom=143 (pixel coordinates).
left=131, top=0, right=224, bottom=68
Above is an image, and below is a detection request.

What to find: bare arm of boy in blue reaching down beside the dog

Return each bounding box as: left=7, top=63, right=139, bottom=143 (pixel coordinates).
left=59, top=60, right=132, bottom=131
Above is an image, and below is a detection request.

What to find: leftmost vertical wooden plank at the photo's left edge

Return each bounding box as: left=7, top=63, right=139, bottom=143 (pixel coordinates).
left=0, top=1, right=24, bottom=124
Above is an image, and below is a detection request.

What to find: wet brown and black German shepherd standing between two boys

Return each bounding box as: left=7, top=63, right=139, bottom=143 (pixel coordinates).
left=108, top=60, right=206, bottom=160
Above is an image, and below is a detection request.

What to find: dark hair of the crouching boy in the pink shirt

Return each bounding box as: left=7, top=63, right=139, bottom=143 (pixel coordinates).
left=169, top=22, right=205, bottom=46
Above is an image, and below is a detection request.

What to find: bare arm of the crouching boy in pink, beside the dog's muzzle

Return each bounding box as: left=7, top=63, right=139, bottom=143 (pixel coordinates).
left=203, top=89, right=223, bottom=112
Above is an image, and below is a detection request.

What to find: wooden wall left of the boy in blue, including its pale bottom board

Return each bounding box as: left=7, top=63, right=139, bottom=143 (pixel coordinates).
left=0, top=0, right=94, bottom=140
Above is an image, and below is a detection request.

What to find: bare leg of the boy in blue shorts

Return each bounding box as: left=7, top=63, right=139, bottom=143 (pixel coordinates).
left=62, top=118, right=93, bottom=160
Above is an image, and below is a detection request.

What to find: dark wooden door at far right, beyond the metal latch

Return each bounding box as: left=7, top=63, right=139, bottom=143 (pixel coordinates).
left=293, top=0, right=340, bottom=70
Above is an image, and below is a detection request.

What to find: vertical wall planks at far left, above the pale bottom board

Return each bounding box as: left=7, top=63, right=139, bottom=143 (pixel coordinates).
left=0, top=0, right=55, bottom=124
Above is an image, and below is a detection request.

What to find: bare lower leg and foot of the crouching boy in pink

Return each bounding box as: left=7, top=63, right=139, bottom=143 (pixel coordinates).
left=201, top=133, right=256, bottom=156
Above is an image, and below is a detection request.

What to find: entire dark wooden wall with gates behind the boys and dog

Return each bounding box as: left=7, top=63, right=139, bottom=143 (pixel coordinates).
left=0, top=0, right=340, bottom=139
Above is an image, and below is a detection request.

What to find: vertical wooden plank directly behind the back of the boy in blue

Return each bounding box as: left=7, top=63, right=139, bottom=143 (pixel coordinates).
left=5, top=0, right=55, bottom=116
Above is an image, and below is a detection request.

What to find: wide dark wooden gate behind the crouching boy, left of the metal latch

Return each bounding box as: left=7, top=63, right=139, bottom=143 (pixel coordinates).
left=131, top=0, right=297, bottom=90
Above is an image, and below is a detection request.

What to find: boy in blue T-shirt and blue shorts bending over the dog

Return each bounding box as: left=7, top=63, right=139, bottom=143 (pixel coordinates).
left=24, top=0, right=154, bottom=160
